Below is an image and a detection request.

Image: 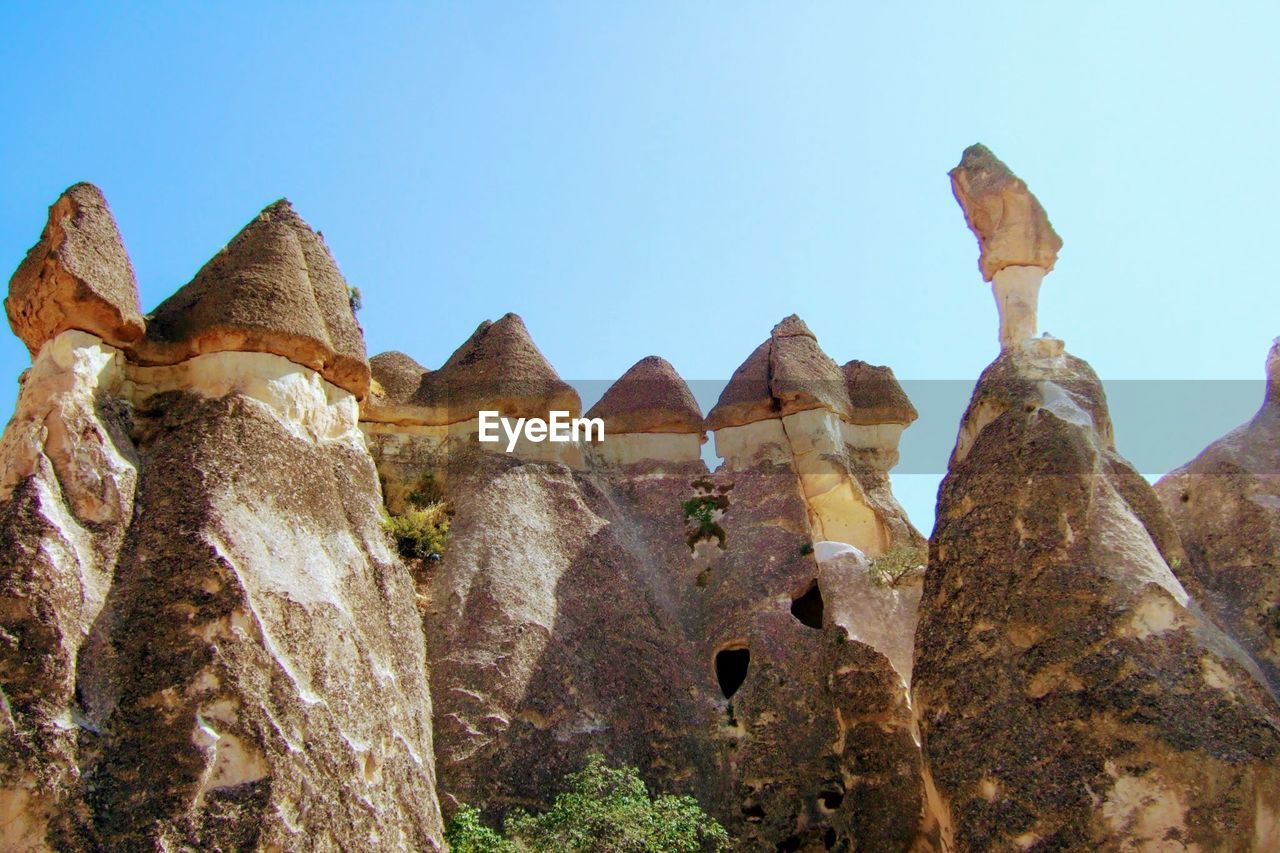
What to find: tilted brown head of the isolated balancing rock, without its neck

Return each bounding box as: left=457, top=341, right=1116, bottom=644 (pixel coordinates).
left=948, top=145, right=1062, bottom=282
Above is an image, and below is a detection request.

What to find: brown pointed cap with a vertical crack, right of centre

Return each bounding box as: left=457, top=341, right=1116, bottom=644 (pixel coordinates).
left=707, top=314, right=852, bottom=429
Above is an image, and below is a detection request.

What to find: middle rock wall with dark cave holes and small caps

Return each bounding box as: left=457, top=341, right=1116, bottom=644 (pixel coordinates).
left=361, top=318, right=922, bottom=849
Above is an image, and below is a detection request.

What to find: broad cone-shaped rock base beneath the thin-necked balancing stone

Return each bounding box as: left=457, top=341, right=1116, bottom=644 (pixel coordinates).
left=911, top=342, right=1280, bottom=850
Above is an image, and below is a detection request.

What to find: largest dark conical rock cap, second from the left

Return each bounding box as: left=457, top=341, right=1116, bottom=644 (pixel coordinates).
left=138, top=199, right=369, bottom=397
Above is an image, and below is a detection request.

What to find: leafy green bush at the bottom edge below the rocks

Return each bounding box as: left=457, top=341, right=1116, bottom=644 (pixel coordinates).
left=444, top=754, right=730, bottom=853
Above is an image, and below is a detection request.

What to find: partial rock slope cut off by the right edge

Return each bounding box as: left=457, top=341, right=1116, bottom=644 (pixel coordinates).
left=1156, top=342, right=1280, bottom=695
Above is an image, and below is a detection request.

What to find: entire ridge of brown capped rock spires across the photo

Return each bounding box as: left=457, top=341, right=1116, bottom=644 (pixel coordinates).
left=0, top=146, right=1280, bottom=852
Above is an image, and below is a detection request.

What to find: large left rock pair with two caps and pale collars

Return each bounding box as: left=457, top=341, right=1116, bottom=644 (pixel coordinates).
left=0, top=184, right=440, bottom=850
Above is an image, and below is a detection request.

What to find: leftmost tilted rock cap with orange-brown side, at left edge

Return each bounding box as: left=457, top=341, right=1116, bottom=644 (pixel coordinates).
left=4, top=183, right=143, bottom=355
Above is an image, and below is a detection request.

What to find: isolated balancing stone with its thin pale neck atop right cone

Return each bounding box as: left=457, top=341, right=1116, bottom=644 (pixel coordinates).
left=950, top=145, right=1062, bottom=348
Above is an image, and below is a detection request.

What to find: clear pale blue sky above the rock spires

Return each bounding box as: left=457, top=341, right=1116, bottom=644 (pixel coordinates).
left=0, top=3, right=1280, bottom=530
